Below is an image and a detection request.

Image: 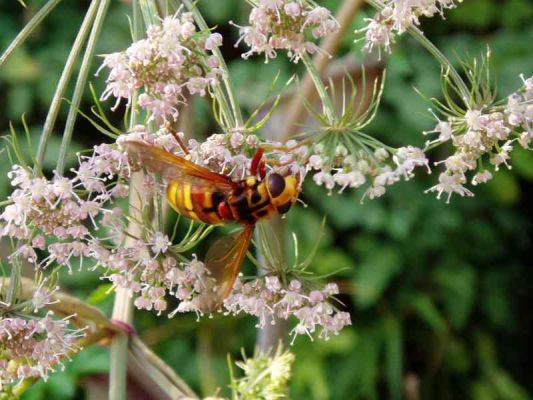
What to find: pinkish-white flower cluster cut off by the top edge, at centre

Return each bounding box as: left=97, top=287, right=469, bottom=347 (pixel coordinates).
left=236, top=0, right=339, bottom=62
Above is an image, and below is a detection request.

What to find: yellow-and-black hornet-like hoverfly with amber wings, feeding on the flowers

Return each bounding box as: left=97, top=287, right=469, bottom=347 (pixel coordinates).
left=121, top=140, right=300, bottom=308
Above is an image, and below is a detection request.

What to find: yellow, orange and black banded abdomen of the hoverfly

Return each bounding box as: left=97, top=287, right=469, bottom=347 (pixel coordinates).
left=167, top=182, right=227, bottom=225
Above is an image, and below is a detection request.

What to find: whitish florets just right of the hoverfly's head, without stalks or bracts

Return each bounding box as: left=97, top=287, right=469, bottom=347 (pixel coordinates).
left=306, top=143, right=429, bottom=199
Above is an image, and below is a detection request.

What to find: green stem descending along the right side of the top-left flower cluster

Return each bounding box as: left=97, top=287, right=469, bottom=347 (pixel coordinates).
left=181, top=0, right=244, bottom=128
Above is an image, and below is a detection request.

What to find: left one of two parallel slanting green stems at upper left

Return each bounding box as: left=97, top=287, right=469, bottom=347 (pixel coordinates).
left=34, top=0, right=100, bottom=171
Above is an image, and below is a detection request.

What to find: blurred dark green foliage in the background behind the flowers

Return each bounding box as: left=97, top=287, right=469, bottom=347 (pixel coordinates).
left=0, top=0, right=533, bottom=400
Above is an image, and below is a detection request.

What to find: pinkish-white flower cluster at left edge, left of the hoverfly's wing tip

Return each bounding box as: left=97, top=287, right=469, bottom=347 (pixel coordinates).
left=0, top=144, right=130, bottom=271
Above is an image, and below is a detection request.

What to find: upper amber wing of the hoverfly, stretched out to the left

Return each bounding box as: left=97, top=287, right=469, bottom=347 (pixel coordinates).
left=122, top=140, right=235, bottom=191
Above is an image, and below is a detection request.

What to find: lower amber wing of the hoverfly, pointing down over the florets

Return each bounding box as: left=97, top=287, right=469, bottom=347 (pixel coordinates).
left=205, top=225, right=254, bottom=309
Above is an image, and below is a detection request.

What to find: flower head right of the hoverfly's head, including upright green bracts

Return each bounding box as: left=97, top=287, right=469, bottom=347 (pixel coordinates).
left=305, top=73, right=429, bottom=199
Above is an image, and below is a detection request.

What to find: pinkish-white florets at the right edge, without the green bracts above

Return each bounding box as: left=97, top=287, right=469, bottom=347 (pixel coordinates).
left=426, top=77, right=533, bottom=202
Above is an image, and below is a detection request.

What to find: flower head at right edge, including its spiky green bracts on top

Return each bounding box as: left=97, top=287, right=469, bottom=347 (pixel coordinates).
left=425, top=54, right=533, bottom=202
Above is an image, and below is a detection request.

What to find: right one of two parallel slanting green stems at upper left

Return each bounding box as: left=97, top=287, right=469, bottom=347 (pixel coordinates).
left=56, top=0, right=110, bottom=175
